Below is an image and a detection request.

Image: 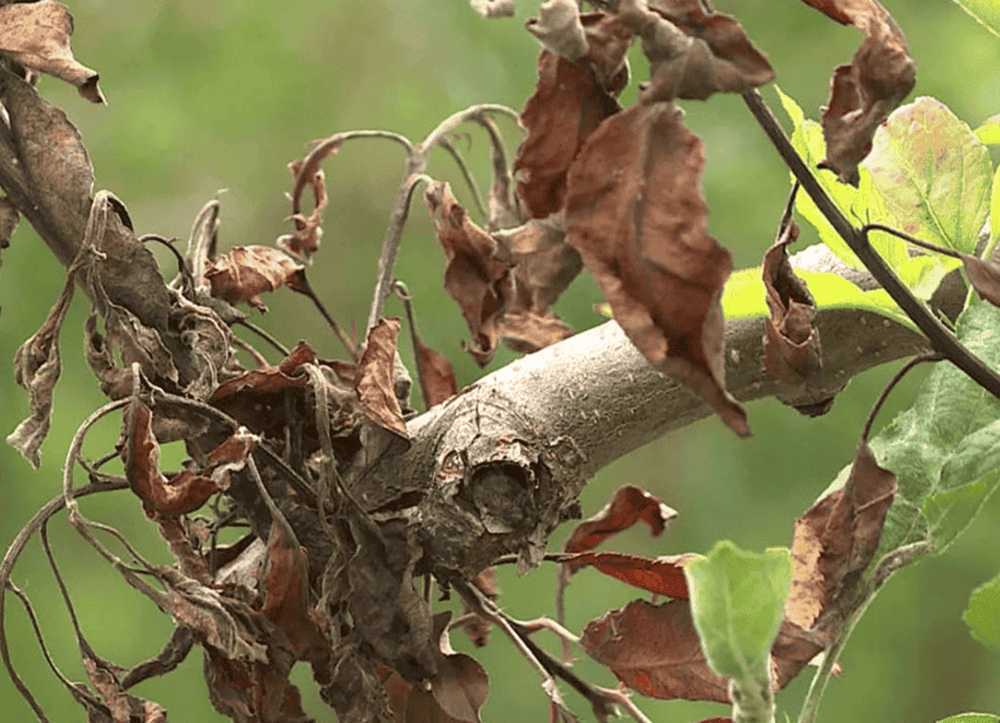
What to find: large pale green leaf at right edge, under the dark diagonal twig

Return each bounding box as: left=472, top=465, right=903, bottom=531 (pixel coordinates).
left=870, top=300, right=1000, bottom=557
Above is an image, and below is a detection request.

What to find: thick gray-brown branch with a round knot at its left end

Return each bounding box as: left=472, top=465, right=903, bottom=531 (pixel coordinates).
left=360, top=248, right=965, bottom=574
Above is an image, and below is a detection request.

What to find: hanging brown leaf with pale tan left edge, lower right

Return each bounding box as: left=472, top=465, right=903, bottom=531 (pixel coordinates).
left=785, top=442, right=896, bottom=630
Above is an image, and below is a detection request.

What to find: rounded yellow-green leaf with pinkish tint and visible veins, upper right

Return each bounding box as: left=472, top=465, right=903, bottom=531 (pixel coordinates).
left=863, top=97, right=993, bottom=254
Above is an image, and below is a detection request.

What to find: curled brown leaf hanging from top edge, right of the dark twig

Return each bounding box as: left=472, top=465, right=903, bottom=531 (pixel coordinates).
left=803, top=0, right=917, bottom=186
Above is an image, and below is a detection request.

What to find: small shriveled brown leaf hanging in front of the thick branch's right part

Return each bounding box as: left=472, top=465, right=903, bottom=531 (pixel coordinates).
left=763, top=221, right=823, bottom=384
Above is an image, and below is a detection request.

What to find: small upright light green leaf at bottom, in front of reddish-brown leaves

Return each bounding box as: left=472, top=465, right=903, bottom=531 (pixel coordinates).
left=684, top=540, right=792, bottom=685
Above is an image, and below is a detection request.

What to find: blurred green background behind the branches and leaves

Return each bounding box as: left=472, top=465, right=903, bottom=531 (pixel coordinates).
left=0, top=0, right=1000, bottom=723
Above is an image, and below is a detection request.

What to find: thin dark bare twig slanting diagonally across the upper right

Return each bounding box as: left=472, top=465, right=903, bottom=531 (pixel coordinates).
left=743, top=90, right=1000, bottom=398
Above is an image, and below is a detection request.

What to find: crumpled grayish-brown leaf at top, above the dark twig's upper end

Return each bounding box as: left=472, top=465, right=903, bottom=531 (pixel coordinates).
left=618, top=0, right=774, bottom=103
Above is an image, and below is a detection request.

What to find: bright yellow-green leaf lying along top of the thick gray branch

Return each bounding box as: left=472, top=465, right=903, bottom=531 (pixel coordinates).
left=722, top=268, right=917, bottom=331
